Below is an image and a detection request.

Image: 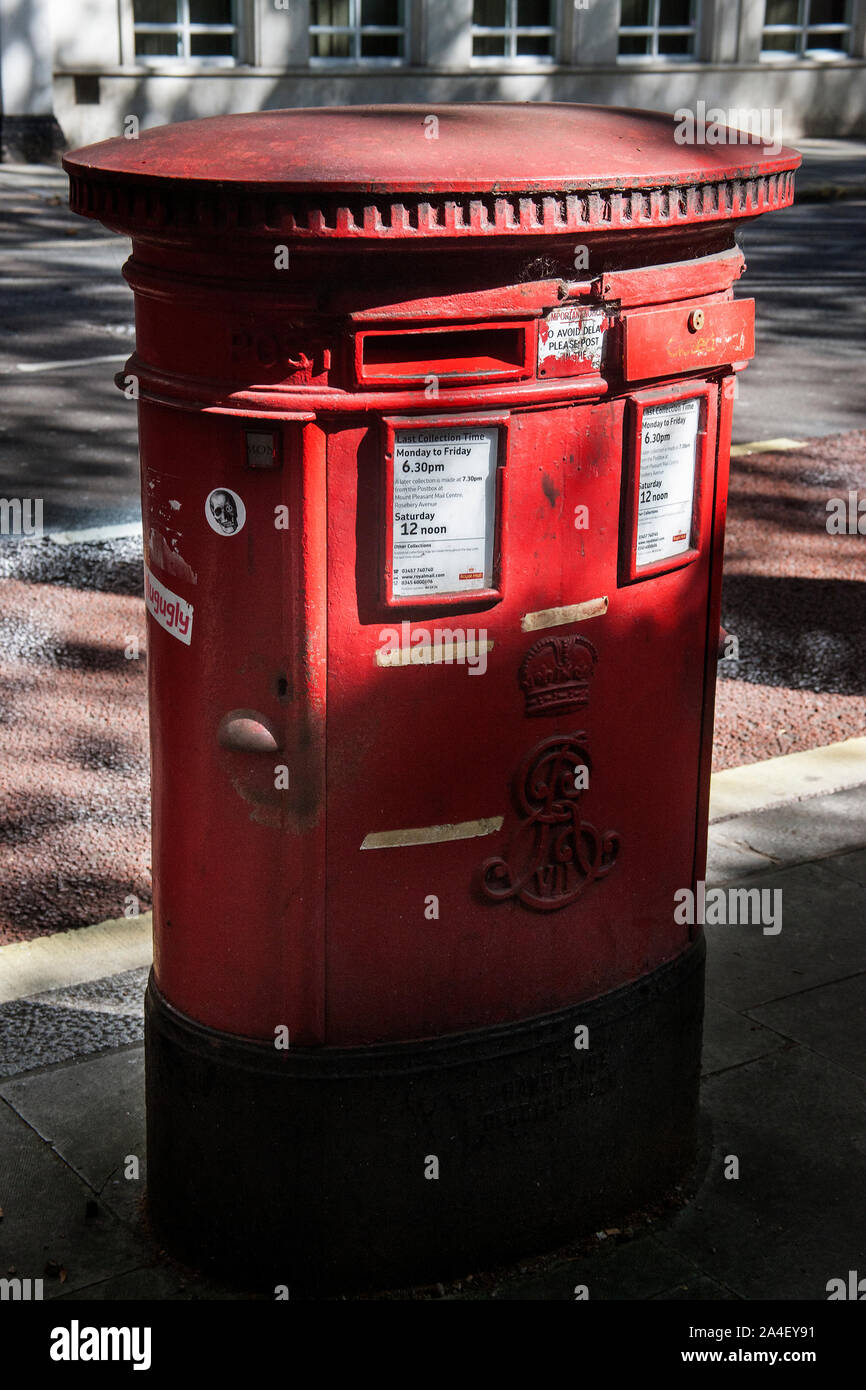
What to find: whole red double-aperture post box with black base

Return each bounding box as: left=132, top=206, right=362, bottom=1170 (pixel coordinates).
left=64, top=104, right=799, bottom=1287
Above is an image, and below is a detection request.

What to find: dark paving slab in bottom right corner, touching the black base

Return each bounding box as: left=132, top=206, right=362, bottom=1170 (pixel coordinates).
left=656, top=1047, right=866, bottom=1300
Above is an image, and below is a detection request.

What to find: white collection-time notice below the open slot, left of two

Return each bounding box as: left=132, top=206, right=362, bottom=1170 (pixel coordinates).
left=392, top=425, right=499, bottom=598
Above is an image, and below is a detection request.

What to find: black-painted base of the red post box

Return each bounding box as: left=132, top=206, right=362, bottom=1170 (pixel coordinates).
left=146, top=940, right=705, bottom=1297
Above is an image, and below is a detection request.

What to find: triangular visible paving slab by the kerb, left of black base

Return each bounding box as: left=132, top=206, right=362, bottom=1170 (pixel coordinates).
left=0, top=1047, right=146, bottom=1225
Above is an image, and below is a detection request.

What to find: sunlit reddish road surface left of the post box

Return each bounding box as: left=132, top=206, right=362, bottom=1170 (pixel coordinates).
left=0, top=580, right=150, bottom=944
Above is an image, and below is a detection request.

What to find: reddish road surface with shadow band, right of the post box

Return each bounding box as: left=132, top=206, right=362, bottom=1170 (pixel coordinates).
left=713, top=431, right=866, bottom=769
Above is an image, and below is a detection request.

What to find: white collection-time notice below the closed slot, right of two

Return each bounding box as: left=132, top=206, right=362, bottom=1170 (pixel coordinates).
left=635, top=398, right=701, bottom=566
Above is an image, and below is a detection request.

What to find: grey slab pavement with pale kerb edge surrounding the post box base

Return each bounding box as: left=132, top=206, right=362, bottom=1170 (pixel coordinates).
left=0, top=739, right=866, bottom=1295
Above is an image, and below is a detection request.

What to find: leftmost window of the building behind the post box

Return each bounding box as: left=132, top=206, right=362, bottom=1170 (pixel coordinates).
left=132, top=0, right=238, bottom=64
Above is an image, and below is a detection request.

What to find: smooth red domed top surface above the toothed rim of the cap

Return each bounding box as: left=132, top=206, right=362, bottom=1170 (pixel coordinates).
left=67, top=101, right=791, bottom=193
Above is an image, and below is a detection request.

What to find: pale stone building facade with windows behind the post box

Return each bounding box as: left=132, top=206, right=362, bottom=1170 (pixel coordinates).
left=0, top=0, right=866, bottom=157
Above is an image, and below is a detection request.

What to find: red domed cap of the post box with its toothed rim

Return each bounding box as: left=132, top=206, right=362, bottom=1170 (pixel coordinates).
left=63, top=101, right=799, bottom=242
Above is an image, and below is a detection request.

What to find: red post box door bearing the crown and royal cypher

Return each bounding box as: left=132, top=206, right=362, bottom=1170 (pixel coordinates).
left=325, top=381, right=719, bottom=1044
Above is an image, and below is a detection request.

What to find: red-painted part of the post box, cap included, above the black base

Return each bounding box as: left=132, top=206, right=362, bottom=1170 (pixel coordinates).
left=65, top=106, right=799, bottom=1047
